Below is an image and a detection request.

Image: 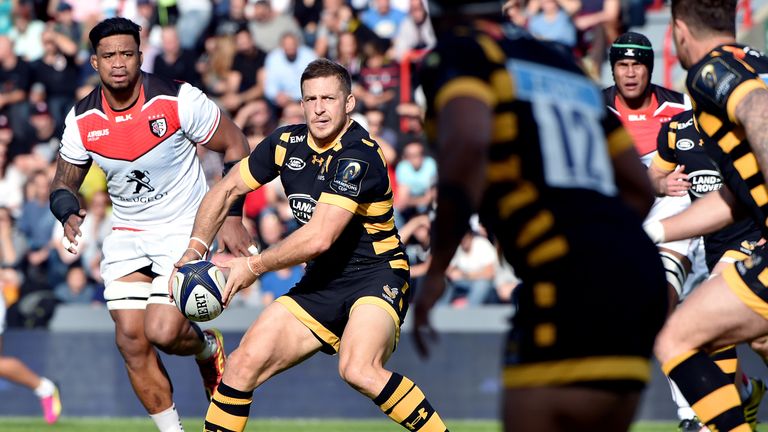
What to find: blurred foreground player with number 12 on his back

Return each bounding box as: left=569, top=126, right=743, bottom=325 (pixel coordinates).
left=414, top=2, right=667, bottom=432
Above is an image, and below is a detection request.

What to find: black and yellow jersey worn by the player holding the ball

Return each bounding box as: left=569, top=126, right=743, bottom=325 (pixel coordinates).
left=240, top=121, right=408, bottom=277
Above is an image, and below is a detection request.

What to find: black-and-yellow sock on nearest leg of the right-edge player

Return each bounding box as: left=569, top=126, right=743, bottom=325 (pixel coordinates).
left=662, top=350, right=751, bottom=432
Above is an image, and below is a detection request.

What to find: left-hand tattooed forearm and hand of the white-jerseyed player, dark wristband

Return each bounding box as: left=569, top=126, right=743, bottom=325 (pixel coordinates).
left=51, top=156, right=91, bottom=253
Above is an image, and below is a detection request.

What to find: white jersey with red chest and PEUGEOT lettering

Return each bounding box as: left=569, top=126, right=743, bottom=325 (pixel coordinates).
left=59, top=73, right=221, bottom=230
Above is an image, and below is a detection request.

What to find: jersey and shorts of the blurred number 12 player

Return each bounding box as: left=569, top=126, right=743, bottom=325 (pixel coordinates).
left=421, top=21, right=666, bottom=388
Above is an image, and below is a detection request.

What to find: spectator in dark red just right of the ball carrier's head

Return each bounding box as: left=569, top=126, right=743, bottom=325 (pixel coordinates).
left=352, top=41, right=400, bottom=128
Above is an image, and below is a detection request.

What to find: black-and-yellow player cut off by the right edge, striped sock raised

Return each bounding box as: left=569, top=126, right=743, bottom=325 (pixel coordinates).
left=655, top=0, right=768, bottom=431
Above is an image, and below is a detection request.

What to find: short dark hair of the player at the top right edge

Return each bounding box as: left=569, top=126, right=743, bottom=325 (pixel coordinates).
left=672, top=0, right=737, bottom=36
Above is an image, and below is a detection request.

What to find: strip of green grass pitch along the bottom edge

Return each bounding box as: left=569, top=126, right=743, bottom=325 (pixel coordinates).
left=0, top=417, right=768, bottom=432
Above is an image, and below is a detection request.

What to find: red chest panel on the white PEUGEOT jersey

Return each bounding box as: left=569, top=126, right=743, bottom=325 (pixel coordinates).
left=77, top=87, right=181, bottom=161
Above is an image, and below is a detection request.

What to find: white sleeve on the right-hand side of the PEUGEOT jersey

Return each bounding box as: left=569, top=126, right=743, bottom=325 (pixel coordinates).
left=179, top=83, right=221, bottom=144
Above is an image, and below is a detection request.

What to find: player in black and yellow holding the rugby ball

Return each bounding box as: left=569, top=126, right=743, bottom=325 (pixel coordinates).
left=172, top=59, right=447, bottom=432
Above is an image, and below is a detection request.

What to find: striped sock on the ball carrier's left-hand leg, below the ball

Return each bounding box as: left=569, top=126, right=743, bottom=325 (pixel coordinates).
left=203, top=382, right=253, bottom=432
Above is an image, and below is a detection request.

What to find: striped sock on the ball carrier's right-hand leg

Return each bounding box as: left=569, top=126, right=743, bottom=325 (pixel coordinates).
left=373, top=373, right=448, bottom=432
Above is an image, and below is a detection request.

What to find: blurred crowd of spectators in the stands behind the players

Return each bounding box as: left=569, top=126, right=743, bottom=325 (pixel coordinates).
left=0, top=0, right=660, bottom=326
